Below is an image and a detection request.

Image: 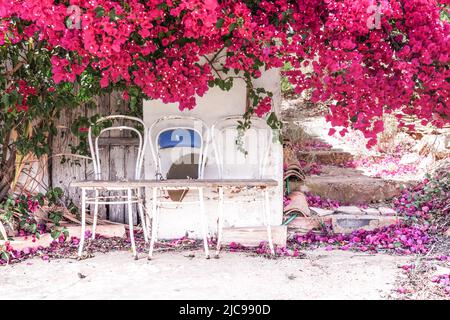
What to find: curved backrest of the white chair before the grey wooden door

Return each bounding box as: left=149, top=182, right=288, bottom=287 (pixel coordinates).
left=88, top=115, right=148, bottom=180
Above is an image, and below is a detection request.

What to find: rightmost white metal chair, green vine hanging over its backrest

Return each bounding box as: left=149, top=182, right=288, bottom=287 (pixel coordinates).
left=211, top=115, right=275, bottom=257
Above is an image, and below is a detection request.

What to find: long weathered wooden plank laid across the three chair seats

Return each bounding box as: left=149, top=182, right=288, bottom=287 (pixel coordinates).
left=70, top=179, right=278, bottom=189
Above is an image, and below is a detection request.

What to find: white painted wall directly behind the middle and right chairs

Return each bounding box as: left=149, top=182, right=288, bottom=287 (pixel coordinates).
left=144, top=70, right=283, bottom=239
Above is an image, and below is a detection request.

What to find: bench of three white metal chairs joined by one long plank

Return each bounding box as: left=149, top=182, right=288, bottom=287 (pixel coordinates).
left=71, top=115, right=278, bottom=259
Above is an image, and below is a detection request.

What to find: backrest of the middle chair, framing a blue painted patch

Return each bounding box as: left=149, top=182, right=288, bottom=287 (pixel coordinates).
left=148, top=115, right=209, bottom=179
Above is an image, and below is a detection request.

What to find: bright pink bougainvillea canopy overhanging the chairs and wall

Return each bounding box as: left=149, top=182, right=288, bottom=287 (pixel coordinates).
left=0, top=0, right=450, bottom=198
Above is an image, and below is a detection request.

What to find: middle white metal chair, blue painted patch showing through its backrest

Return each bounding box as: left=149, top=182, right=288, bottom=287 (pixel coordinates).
left=148, top=116, right=209, bottom=259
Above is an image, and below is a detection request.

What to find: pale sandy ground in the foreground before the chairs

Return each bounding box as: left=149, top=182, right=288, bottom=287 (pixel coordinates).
left=0, top=250, right=407, bottom=299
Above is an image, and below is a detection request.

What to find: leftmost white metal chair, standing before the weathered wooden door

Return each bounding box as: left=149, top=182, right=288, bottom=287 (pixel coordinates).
left=78, top=115, right=148, bottom=259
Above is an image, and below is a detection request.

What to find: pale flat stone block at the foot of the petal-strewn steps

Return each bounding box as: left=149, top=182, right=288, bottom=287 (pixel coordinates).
left=331, top=215, right=398, bottom=233
